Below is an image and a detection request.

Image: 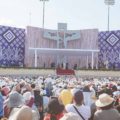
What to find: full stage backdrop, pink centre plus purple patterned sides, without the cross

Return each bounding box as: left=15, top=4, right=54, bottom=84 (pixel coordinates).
left=0, top=26, right=120, bottom=69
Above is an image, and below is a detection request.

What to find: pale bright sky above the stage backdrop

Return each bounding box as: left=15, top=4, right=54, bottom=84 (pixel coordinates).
left=0, top=0, right=120, bottom=31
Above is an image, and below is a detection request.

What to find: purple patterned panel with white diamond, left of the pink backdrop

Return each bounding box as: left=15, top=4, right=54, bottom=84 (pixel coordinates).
left=0, top=26, right=25, bottom=67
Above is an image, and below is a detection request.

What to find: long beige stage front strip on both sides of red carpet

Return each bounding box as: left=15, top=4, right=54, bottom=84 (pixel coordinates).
left=0, top=68, right=120, bottom=77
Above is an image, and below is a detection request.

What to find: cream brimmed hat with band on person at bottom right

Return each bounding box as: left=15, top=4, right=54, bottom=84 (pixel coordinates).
left=96, top=93, right=114, bottom=107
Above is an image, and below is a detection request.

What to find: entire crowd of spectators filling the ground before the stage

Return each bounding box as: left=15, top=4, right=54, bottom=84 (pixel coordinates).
left=0, top=75, right=120, bottom=120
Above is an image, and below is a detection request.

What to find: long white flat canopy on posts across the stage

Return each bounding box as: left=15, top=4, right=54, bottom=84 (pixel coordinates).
left=29, top=48, right=99, bottom=69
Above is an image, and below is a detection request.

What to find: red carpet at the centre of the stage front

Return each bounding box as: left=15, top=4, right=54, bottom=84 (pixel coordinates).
left=56, top=68, right=75, bottom=75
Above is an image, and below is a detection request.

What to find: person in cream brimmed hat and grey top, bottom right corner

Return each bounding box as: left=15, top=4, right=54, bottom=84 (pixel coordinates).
left=94, top=93, right=120, bottom=120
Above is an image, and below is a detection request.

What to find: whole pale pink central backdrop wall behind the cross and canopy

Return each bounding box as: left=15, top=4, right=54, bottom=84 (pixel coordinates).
left=25, top=26, right=98, bottom=68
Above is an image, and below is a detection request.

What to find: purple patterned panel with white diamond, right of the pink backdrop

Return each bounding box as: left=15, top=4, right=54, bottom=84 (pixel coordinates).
left=98, top=30, right=120, bottom=68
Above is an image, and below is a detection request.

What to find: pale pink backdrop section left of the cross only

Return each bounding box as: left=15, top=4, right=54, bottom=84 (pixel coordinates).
left=25, top=26, right=57, bottom=68
